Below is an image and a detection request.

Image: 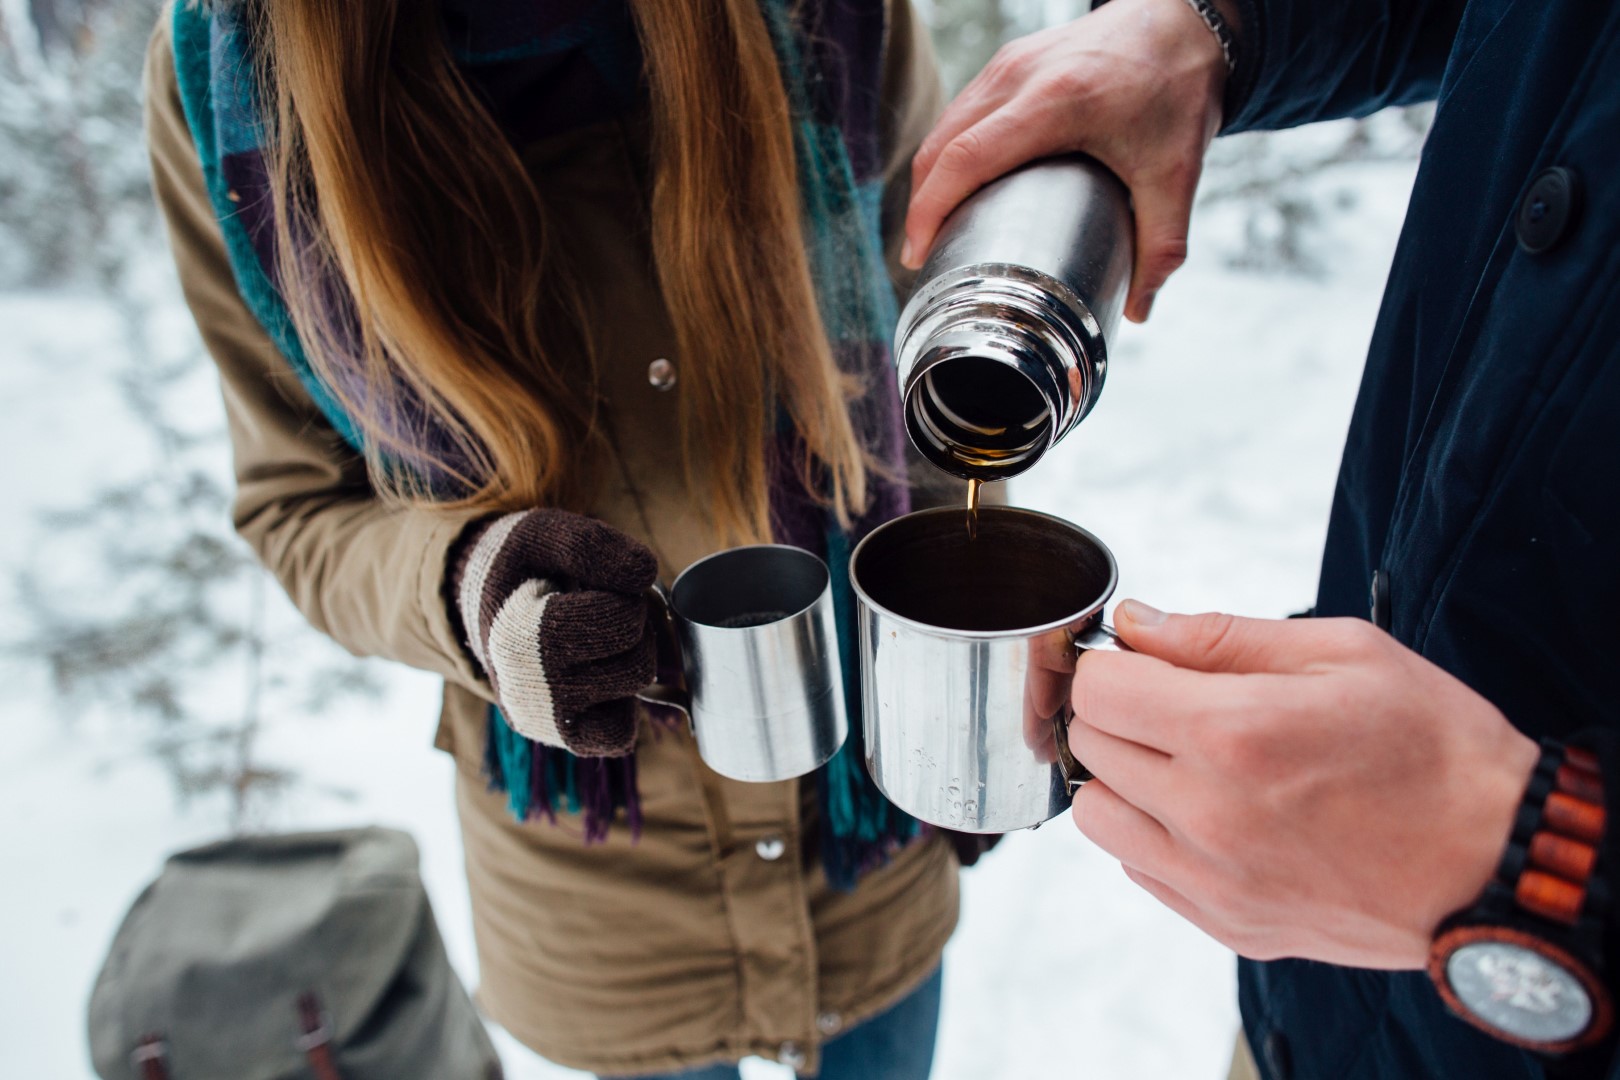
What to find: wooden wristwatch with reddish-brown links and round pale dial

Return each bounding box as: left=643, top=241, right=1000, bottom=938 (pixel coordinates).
left=1429, top=740, right=1614, bottom=1054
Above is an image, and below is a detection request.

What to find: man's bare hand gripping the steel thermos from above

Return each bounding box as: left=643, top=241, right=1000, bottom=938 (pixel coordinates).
left=901, top=0, right=1226, bottom=322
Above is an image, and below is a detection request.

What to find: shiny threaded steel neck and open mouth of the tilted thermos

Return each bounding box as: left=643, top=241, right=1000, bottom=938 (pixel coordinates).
left=896, top=264, right=1106, bottom=481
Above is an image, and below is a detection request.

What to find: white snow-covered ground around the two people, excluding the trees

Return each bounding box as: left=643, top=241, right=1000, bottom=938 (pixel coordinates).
left=0, top=133, right=1413, bottom=1080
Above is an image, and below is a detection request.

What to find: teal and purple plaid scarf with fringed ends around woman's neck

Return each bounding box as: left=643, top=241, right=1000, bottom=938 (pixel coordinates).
left=173, top=0, right=919, bottom=889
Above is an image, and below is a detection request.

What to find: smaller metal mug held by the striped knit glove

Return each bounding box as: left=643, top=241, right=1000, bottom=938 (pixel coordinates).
left=637, top=544, right=849, bottom=782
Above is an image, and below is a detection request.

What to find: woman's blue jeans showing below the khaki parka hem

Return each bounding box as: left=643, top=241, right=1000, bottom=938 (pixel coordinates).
left=603, top=968, right=944, bottom=1080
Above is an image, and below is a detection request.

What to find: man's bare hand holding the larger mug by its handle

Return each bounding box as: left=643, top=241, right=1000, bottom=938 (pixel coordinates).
left=1069, top=601, right=1537, bottom=968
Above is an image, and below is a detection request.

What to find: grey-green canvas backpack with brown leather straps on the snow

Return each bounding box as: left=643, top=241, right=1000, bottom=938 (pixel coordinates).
left=89, top=829, right=501, bottom=1080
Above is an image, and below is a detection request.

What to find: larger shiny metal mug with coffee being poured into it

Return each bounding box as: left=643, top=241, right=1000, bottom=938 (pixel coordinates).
left=849, top=507, right=1124, bottom=832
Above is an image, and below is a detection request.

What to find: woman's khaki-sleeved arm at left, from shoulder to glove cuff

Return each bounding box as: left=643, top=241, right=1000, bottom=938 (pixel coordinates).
left=146, top=16, right=491, bottom=698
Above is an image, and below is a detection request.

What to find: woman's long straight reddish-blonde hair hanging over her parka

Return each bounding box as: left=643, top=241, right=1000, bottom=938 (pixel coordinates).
left=261, top=0, right=867, bottom=541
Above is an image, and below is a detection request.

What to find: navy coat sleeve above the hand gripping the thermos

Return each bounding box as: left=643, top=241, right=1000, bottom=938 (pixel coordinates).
left=1221, top=0, right=1468, bottom=134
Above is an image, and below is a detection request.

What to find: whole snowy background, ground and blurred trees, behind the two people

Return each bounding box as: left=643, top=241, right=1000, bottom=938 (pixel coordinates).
left=0, top=0, right=1424, bottom=1080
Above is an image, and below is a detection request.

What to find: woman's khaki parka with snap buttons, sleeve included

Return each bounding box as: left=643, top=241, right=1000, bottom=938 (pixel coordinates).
left=146, top=0, right=957, bottom=1074
